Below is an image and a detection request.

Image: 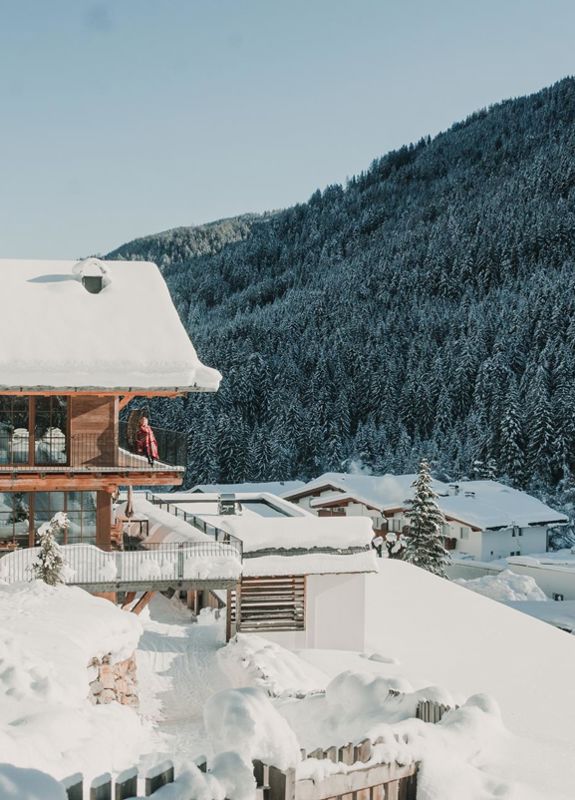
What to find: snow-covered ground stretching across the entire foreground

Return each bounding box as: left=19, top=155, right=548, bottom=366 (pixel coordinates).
left=4, top=559, right=575, bottom=800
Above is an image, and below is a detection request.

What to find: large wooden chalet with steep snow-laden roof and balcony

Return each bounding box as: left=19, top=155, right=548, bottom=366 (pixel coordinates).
left=0, top=258, right=237, bottom=592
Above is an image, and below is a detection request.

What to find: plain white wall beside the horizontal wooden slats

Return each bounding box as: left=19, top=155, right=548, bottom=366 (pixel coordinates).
left=261, top=574, right=365, bottom=650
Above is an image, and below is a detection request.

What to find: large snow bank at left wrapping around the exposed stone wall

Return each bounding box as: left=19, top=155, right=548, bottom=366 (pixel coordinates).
left=0, top=581, right=158, bottom=777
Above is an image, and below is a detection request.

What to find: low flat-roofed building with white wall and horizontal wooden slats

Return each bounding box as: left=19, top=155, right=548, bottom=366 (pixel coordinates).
left=142, top=492, right=377, bottom=650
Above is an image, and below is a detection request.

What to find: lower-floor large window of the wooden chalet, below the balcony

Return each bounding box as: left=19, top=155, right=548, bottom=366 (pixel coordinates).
left=0, top=492, right=96, bottom=547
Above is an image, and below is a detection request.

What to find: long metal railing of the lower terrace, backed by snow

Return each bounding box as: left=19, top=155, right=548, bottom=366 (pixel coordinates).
left=0, top=541, right=241, bottom=587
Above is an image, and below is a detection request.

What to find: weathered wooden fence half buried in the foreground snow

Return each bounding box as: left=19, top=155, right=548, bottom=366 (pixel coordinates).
left=62, top=692, right=451, bottom=800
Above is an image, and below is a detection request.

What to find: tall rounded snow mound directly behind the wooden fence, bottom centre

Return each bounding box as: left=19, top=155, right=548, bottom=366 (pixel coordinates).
left=204, top=687, right=300, bottom=769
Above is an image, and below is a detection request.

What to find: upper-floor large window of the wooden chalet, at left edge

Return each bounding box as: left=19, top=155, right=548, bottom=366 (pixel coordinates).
left=0, top=395, right=68, bottom=466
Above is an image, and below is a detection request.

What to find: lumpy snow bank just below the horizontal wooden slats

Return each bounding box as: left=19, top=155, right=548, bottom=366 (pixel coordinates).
left=218, top=633, right=329, bottom=697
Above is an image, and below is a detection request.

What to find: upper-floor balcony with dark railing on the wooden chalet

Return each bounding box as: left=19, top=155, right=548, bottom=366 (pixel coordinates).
left=0, top=422, right=187, bottom=475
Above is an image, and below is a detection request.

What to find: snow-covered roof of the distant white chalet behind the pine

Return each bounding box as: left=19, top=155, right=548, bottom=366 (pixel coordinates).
left=283, top=472, right=567, bottom=530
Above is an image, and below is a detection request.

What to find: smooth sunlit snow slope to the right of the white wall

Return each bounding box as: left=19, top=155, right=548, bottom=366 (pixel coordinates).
left=301, top=559, right=575, bottom=800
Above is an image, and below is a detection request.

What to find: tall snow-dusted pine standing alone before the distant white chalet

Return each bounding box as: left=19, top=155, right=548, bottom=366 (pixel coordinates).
left=402, top=459, right=449, bottom=577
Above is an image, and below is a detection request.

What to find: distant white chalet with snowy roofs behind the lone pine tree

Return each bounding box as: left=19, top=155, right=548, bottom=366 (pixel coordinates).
left=283, top=473, right=567, bottom=561
